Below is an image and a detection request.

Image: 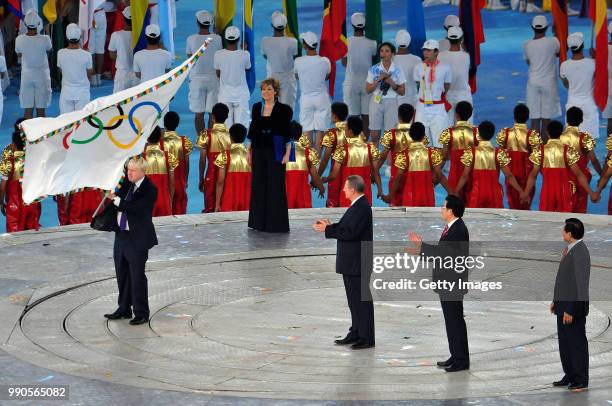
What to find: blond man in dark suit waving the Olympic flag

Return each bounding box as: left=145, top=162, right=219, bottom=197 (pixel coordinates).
left=104, top=158, right=157, bottom=326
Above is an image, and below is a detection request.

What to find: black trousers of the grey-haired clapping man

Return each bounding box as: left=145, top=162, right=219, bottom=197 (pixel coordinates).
left=342, top=275, right=375, bottom=344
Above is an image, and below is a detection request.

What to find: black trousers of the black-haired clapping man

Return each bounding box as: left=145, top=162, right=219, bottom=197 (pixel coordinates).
left=440, top=300, right=470, bottom=367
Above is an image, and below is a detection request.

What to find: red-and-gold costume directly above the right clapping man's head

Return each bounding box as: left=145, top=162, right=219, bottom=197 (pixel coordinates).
left=440, top=121, right=478, bottom=202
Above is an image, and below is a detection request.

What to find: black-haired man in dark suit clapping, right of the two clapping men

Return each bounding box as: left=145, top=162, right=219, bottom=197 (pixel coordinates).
left=407, top=195, right=470, bottom=372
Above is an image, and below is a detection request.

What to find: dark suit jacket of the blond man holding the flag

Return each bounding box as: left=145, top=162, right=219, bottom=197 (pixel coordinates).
left=112, top=176, right=157, bottom=251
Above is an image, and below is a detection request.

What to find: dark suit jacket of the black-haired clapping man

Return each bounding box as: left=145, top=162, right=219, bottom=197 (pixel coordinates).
left=421, top=218, right=470, bottom=299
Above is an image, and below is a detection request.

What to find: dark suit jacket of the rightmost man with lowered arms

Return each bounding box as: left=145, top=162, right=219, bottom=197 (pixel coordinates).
left=553, top=241, right=591, bottom=316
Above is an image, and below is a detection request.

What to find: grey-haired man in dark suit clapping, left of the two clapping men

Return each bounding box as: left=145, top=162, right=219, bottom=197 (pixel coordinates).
left=313, top=175, right=375, bottom=350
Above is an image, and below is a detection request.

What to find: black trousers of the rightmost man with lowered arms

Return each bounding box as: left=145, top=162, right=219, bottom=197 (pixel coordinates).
left=557, top=311, right=589, bottom=385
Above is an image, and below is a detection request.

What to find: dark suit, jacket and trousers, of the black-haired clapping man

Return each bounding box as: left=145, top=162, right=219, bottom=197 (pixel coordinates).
left=421, top=219, right=470, bottom=367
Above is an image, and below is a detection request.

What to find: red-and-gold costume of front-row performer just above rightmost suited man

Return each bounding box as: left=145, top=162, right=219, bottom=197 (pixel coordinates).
left=529, top=139, right=581, bottom=212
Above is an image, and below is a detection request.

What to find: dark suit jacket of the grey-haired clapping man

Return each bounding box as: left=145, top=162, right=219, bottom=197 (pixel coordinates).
left=325, top=196, right=373, bottom=276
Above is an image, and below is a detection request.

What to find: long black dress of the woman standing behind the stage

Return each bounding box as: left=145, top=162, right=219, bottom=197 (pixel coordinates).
left=248, top=102, right=293, bottom=233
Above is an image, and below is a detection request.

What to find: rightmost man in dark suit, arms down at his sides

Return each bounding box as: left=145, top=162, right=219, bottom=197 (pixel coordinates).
left=550, top=218, right=591, bottom=391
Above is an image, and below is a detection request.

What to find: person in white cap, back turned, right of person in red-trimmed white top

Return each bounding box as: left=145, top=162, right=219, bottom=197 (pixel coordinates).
left=438, top=27, right=474, bottom=123
